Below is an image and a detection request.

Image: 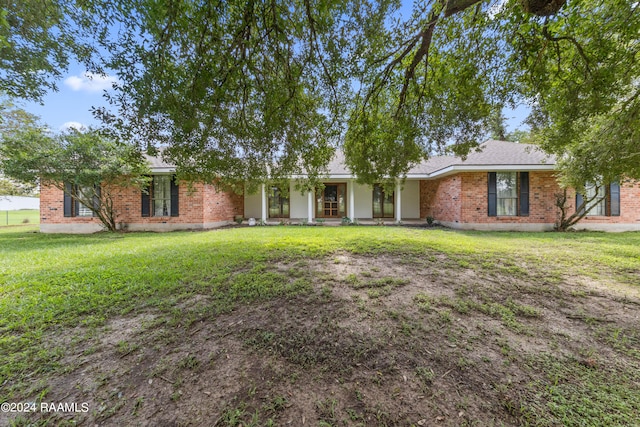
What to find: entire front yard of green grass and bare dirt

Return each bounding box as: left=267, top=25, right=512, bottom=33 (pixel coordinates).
left=0, top=226, right=640, bottom=426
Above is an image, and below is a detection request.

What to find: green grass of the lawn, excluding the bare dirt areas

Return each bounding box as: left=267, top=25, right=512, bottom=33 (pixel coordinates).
left=0, top=226, right=640, bottom=425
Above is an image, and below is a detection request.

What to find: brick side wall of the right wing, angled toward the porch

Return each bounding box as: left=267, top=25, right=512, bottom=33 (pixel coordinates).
left=420, top=175, right=462, bottom=222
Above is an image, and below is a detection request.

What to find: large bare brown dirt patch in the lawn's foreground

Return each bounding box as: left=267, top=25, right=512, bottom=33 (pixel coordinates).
left=6, top=253, right=640, bottom=426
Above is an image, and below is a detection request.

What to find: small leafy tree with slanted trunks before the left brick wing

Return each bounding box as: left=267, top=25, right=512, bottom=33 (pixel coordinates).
left=0, top=126, right=149, bottom=231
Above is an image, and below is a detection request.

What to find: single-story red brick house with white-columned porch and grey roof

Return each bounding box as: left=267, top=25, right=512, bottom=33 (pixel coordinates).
left=40, top=140, right=640, bottom=233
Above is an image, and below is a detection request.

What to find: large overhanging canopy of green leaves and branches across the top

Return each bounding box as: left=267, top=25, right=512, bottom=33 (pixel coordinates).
left=3, top=0, right=640, bottom=189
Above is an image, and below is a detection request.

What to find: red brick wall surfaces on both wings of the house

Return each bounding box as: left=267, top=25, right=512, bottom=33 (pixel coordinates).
left=40, top=171, right=640, bottom=232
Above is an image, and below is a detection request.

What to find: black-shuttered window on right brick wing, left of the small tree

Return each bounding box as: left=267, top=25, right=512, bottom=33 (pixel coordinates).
left=487, top=172, right=529, bottom=216
